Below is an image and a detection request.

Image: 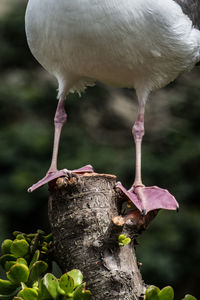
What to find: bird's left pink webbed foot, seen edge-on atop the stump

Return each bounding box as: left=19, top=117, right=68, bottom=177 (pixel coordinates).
left=28, top=165, right=94, bottom=193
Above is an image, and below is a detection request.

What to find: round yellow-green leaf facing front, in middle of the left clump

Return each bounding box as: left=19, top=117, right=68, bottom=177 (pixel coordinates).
left=7, top=264, right=29, bottom=284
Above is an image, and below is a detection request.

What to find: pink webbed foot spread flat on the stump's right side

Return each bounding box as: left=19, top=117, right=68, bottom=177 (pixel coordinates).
left=116, top=182, right=179, bottom=215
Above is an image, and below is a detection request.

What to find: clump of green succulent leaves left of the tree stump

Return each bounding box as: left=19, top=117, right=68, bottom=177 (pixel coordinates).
left=0, top=230, right=91, bottom=300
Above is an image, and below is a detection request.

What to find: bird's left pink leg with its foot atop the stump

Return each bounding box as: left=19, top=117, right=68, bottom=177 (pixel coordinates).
left=28, top=96, right=93, bottom=192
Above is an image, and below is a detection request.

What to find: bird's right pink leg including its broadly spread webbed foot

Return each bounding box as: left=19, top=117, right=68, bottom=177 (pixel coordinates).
left=116, top=105, right=179, bottom=216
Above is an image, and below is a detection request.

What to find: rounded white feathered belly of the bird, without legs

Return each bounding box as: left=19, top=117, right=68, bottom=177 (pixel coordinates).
left=26, top=0, right=200, bottom=94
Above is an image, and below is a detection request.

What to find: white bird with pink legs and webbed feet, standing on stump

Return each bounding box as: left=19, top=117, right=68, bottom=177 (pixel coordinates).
left=25, top=0, right=200, bottom=214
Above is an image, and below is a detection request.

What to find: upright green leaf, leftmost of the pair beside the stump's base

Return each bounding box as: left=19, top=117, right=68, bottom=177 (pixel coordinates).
left=43, top=273, right=65, bottom=299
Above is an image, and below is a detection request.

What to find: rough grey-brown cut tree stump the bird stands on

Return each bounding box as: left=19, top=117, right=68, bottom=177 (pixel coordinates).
left=49, top=174, right=155, bottom=300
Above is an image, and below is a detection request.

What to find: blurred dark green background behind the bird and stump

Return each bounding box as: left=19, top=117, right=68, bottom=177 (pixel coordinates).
left=0, top=0, right=200, bottom=299
